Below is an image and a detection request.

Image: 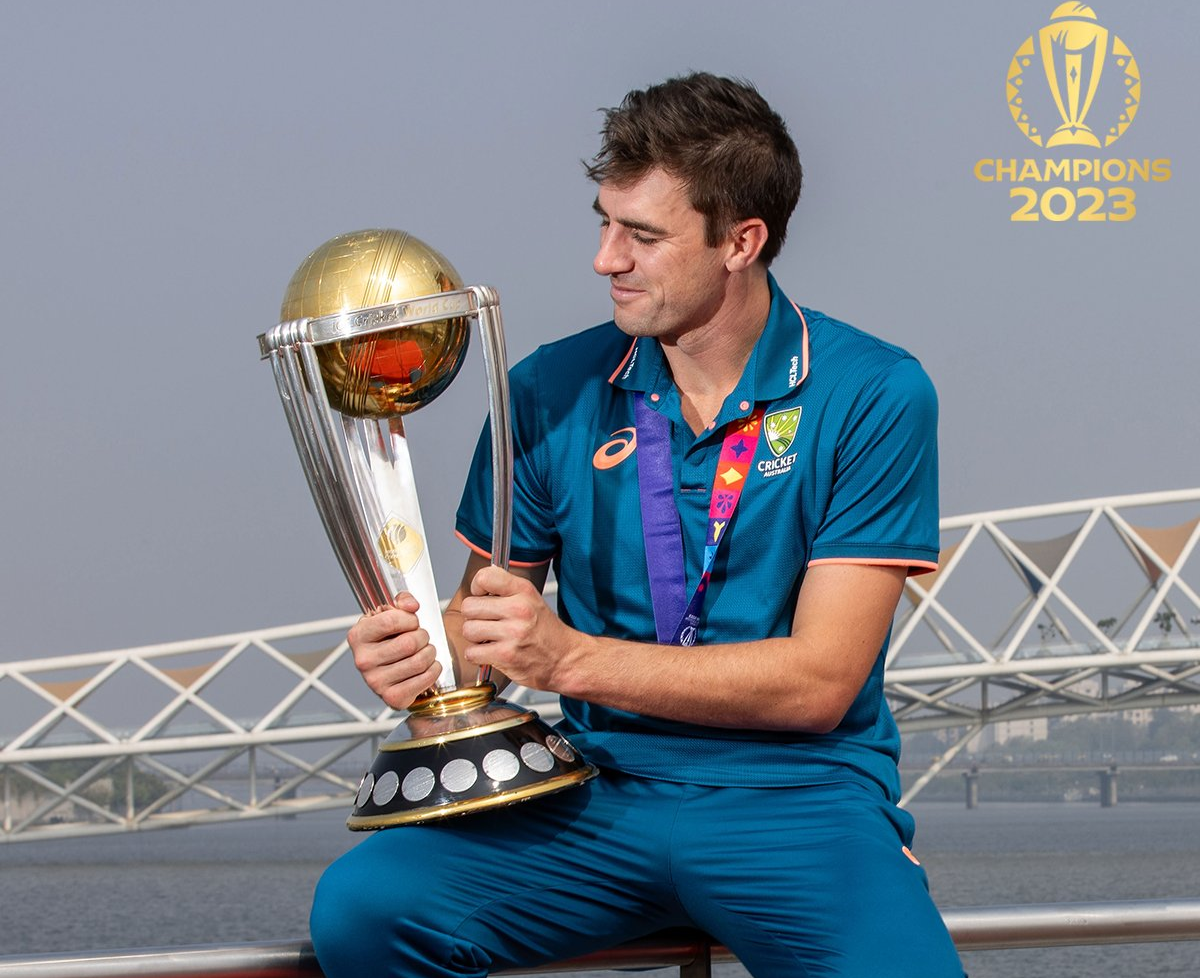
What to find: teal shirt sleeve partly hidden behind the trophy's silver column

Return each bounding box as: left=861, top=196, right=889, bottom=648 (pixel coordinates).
left=455, top=353, right=559, bottom=566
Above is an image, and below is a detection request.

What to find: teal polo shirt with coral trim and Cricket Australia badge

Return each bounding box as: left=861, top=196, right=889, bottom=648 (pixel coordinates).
left=457, top=278, right=938, bottom=797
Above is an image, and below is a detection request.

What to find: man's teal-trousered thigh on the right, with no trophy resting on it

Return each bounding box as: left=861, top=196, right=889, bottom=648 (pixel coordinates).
left=672, top=782, right=962, bottom=978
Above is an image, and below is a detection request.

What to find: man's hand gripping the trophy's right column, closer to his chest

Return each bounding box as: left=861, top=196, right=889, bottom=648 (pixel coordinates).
left=460, top=566, right=581, bottom=692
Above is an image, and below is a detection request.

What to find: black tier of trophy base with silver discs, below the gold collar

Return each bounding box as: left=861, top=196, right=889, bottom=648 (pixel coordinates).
left=346, top=712, right=596, bottom=830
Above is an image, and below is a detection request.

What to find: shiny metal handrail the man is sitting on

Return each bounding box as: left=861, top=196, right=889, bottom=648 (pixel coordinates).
left=0, top=899, right=1200, bottom=978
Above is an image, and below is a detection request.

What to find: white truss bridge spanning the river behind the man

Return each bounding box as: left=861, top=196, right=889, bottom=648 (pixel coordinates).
left=0, top=488, right=1200, bottom=841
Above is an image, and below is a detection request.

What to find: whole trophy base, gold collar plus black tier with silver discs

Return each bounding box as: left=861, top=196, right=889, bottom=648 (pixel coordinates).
left=346, top=683, right=596, bottom=832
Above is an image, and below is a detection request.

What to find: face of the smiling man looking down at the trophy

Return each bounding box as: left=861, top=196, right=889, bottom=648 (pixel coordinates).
left=592, top=169, right=728, bottom=341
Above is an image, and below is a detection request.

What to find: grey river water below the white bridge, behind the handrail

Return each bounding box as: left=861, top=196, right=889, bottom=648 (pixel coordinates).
left=0, top=803, right=1200, bottom=978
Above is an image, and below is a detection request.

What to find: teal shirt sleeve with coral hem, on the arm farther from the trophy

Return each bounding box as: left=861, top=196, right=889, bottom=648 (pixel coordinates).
left=809, top=358, right=940, bottom=574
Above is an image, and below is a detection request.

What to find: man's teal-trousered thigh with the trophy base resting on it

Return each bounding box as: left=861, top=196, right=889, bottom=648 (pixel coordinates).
left=312, top=772, right=685, bottom=978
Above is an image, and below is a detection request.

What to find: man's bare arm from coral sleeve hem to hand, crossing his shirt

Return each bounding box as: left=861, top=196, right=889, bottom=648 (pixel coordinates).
left=460, top=564, right=905, bottom=732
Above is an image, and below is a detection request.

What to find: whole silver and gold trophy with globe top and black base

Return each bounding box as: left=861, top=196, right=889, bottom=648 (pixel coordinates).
left=258, top=229, right=595, bottom=829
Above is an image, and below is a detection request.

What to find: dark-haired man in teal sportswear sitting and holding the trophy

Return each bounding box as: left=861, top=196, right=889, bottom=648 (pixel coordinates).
left=312, top=74, right=962, bottom=978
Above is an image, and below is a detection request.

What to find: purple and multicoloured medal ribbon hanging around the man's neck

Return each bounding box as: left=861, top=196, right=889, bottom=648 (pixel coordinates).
left=634, top=394, right=762, bottom=646
